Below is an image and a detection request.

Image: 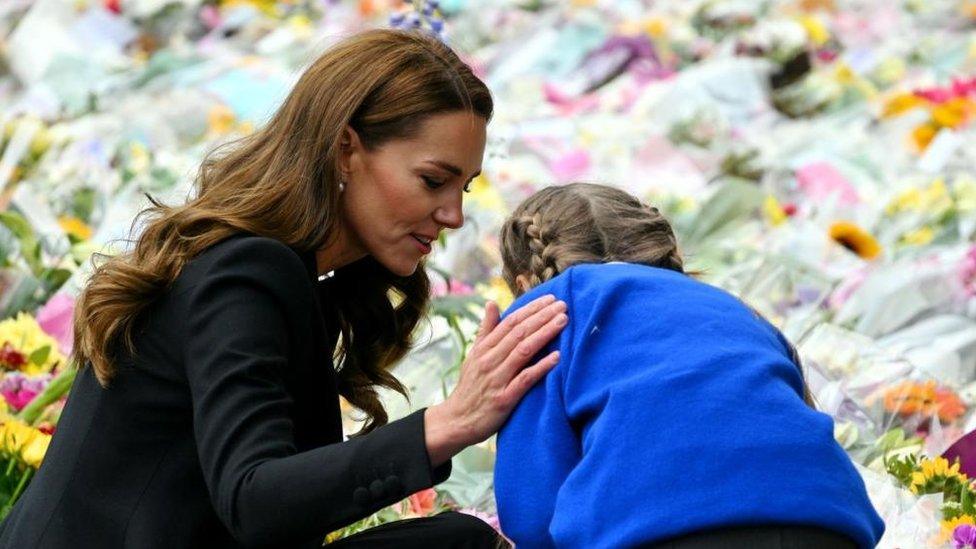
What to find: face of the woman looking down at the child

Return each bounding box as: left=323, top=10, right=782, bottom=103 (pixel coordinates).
left=331, top=111, right=486, bottom=276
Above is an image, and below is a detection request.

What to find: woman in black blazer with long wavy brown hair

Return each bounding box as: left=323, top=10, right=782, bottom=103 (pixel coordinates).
left=0, top=31, right=567, bottom=549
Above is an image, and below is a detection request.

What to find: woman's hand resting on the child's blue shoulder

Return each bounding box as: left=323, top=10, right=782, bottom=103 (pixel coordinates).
left=424, top=295, right=567, bottom=467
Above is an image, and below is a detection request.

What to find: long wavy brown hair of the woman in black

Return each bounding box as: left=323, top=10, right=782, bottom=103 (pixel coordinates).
left=74, top=30, right=493, bottom=432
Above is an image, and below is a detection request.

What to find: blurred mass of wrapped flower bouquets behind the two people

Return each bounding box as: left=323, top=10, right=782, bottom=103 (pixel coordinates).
left=0, top=0, right=976, bottom=547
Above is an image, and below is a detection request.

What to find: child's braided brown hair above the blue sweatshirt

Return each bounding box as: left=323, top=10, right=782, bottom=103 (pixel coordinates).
left=501, top=183, right=685, bottom=294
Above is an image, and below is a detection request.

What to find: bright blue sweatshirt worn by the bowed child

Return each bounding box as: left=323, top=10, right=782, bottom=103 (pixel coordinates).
left=495, top=263, right=884, bottom=549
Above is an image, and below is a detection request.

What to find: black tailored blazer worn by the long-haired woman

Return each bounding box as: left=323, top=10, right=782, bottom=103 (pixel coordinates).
left=0, top=236, right=450, bottom=549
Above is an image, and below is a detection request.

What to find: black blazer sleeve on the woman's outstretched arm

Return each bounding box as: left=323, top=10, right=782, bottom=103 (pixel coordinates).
left=184, top=238, right=450, bottom=546
